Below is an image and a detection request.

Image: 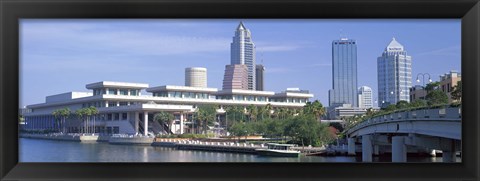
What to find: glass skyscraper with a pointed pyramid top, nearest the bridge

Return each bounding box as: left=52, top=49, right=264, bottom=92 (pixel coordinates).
left=377, top=38, right=412, bottom=107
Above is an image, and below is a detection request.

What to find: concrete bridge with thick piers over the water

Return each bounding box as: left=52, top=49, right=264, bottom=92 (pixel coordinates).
left=346, top=107, right=462, bottom=162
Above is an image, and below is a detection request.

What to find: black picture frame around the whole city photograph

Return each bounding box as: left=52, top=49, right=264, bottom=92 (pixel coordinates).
left=0, top=0, right=480, bottom=180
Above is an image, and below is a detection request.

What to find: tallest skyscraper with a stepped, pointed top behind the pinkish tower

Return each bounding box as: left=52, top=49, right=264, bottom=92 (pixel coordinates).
left=230, top=22, right=256, bottom=90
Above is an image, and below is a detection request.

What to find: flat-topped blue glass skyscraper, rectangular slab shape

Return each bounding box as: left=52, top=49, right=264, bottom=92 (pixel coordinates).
left=328, top=38, right=358, bottom=107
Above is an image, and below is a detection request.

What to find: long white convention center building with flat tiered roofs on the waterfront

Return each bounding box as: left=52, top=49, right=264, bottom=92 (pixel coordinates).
left=21, top=81, right=313, bottom=135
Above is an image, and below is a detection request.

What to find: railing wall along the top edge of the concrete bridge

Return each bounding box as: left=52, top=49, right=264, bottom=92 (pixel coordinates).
left=347, top=107, right=462, bottom=134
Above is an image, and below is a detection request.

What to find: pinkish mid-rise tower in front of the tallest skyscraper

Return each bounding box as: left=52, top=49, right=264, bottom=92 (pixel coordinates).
left=222, top=64, right=248, bottom=90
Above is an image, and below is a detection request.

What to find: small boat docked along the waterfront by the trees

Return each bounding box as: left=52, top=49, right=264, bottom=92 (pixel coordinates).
left=255, top=143, right=300, bottom=157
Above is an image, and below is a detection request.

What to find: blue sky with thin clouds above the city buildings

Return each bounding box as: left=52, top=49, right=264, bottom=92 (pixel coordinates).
left=20, top=19, right=461, bottom=106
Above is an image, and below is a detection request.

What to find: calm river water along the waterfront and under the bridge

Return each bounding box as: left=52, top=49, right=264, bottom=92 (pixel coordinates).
left=19, top=138, right=459, bottom=162
